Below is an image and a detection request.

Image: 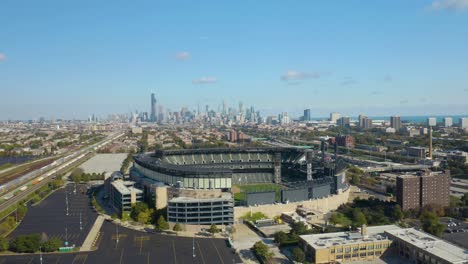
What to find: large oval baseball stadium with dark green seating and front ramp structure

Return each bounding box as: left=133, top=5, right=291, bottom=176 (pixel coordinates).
left=130, top=147, right=347, bottom=224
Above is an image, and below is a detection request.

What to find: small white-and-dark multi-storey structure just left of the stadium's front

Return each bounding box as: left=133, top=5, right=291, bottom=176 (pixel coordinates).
left=109, top=180, right=143, bottom=216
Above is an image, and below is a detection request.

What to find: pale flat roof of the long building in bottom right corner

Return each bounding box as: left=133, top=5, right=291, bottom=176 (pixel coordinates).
left=385, top=228, right=468, bottom=263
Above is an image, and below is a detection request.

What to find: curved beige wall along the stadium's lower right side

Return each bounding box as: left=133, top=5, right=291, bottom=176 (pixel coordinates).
left=234, top=188, right=350, bottom=221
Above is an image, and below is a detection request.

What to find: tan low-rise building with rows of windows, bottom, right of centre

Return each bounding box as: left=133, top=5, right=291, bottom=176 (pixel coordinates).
left=299, top=225, right=401, bottom=264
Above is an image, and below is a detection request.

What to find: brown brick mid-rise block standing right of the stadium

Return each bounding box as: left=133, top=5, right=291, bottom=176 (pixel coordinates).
left=396, top=171, right=450, bottom=210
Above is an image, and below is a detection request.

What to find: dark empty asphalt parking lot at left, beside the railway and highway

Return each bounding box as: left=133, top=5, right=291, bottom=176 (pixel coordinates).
left=9, top=184, right=97, bottom=246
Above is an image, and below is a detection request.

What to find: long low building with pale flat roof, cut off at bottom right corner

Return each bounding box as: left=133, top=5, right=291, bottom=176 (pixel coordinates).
left=385, top=228, right=468, bottom=264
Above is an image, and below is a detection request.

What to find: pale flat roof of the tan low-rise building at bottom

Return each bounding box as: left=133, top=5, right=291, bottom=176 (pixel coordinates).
left=300, top=225, right=401, bottom=249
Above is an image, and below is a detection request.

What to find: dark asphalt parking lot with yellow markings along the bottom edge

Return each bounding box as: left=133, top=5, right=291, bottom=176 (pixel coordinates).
left=0, top=222, right=241, bottom=264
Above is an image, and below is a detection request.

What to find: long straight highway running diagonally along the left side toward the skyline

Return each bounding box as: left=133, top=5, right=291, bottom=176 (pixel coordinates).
left=0, top=133, right=124, bottom=212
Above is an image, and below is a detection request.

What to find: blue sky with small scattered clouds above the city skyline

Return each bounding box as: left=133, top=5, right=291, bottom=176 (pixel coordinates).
left=0, top=0, right=468, bottom=120
